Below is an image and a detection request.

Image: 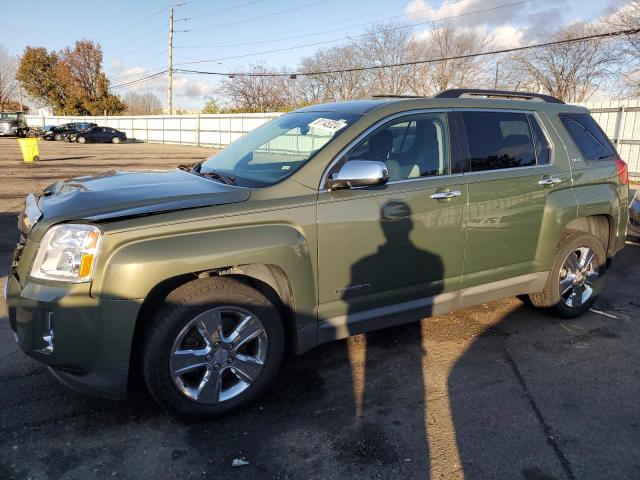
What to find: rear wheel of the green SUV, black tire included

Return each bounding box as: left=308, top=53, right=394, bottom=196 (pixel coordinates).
left=529, top=230, right=606, bottom=318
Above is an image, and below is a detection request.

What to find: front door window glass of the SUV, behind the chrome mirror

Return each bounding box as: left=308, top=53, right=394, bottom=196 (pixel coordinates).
left=346, top=113, right=449, bottom=181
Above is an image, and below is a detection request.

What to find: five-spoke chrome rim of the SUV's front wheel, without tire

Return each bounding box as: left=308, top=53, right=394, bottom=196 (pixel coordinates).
left=169, top=306, right=267, bottom=404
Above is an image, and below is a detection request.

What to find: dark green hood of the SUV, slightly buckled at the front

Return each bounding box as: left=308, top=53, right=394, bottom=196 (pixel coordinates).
left=38, top=169, right=251, bottom=221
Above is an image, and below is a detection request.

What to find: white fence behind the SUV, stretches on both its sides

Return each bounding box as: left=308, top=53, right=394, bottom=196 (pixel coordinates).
left=27, top=100, right=640, bottom=180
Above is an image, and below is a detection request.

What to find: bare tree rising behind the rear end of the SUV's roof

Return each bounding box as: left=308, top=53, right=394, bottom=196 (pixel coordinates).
left=510, top=24, right=618, bottom=102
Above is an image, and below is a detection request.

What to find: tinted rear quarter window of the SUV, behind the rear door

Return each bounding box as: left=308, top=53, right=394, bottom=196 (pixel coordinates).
left=560, top=113, right=615, bottom=160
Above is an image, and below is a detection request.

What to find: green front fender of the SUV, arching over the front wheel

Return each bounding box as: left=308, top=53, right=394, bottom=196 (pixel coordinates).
left=92, top=223, right=317, bottom=328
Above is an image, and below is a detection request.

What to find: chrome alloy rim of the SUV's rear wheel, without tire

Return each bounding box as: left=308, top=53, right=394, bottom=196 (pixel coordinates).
left=559, top=247, right=599, bottom=308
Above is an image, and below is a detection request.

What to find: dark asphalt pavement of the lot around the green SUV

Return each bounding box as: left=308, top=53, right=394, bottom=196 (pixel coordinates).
left=0, top=140, right=640, bottom=480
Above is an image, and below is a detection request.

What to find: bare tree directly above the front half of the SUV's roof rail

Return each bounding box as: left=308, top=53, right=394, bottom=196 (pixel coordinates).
left=406, top=23, right=489, bottom=95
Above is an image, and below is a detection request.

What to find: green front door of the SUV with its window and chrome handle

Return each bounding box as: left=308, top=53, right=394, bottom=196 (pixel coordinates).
left=318, top=112, right=466, bottom=337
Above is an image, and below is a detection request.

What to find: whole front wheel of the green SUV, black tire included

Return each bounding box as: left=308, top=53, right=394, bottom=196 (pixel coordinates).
left=142, top=277, right=285, bottom=419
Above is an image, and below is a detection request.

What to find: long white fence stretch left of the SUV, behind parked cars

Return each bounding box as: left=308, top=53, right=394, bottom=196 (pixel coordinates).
left=27, top=113, right=281, bottom=147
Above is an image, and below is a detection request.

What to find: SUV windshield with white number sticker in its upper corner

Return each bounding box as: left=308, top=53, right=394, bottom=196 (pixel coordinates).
left=200, top=112, right=360, bottom=187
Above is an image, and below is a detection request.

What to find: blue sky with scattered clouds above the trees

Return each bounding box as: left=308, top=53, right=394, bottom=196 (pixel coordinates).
left=0, top=0, right=618, bottom=109
